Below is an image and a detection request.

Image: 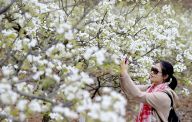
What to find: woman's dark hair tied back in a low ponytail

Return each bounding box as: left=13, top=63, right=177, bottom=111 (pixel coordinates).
left=160, top=61, right=177, bottom=90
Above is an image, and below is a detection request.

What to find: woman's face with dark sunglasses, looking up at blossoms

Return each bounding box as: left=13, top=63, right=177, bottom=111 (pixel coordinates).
left=149, top=63, right=164, bottom=84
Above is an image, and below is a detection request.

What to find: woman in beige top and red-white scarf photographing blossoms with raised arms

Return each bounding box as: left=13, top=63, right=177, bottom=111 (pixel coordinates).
left=120, top=60, right=178, bottom=122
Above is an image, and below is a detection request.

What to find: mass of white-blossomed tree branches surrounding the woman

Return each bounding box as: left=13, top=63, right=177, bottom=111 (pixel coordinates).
left=0, top=0, right=192, bottom=122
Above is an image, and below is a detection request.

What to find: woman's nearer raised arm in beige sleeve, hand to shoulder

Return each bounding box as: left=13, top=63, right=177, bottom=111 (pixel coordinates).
left=120, top=61, right=170, bottom=108
